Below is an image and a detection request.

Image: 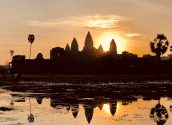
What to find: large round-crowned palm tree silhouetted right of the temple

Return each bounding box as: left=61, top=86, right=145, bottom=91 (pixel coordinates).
left=150, top=34, right=169, bottom=59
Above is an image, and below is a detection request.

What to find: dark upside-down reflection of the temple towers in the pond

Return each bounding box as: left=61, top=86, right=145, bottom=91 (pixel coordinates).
left=45, top=95, right=117, bottom=123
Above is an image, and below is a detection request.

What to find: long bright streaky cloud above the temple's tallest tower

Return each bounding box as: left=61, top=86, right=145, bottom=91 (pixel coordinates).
left=29, top=14, right=125, bottom=28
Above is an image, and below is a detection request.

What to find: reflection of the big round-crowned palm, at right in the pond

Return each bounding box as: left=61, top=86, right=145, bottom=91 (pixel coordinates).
left=150, top=100, right=169, bottom=125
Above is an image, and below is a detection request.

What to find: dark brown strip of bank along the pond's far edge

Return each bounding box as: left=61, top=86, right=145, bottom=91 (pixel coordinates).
left=0, top=74, right=172, bottom=87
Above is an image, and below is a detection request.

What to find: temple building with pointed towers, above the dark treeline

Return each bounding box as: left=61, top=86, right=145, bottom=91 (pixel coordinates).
left=50, top=32, right=113, bottom=61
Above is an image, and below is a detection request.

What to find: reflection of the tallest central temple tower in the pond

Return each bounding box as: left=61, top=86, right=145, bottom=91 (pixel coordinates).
left=84, top=104, right=94, bottom=123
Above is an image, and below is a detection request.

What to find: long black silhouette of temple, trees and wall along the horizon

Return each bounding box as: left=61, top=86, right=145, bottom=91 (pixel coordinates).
left=11, top=32, right=172, bottom=74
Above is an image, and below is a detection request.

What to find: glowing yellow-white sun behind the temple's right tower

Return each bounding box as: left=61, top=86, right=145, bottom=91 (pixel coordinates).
left=97, top=33, right=126, bottom=53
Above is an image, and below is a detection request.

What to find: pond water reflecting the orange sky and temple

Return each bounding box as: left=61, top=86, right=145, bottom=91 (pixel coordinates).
left=0, top=82, right=172, bottom=125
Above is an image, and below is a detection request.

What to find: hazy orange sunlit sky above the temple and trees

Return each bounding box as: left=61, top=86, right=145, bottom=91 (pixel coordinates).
left=0, top=0, right=172, bottom=64
